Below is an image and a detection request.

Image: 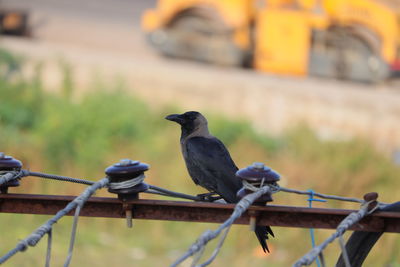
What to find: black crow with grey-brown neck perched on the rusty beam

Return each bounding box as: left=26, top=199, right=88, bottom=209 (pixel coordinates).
left=165, top=111, right=274, bottom=252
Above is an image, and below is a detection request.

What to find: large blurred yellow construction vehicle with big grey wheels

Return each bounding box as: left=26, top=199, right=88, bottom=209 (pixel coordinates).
left=142, top=0, right=400, bottom=82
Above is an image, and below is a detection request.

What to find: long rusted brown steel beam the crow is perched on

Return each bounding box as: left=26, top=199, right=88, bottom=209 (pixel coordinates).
left=0, top=194, right=400, bottom=233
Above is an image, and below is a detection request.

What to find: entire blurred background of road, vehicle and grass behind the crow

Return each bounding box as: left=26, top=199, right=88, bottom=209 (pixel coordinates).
left=0, top=0, right=400, bottom=267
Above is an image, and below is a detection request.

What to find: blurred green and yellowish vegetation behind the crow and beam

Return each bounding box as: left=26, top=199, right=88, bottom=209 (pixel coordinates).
left=0, top=52, right=400, bottom=267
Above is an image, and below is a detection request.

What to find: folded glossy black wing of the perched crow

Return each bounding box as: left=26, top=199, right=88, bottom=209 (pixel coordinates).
left=184, top=136, right=241, bottom=203
